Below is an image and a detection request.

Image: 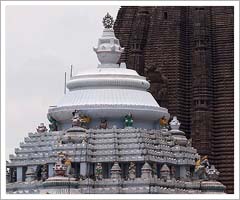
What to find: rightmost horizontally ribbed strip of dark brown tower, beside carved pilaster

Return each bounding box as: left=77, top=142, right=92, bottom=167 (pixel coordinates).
left=211, top=6, right=233, bottom=192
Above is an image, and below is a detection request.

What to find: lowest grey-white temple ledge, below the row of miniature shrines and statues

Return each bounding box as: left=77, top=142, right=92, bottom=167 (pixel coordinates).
left=7, top=177, right=225, bottom=194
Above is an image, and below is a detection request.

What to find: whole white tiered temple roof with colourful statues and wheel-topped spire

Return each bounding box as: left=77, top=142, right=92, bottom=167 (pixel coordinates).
left=6, top=13, right=225, bottom=194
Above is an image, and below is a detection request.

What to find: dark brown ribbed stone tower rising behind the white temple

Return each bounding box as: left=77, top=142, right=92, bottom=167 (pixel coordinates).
left=114, top=6, right=234, bottom=193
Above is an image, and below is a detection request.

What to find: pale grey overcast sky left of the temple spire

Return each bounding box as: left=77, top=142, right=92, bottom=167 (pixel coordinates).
left=5, top=5, right=120, bottom=160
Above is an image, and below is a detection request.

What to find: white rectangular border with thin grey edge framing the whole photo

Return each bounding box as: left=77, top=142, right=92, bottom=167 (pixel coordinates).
left=1, top=1, right=239, bottom=199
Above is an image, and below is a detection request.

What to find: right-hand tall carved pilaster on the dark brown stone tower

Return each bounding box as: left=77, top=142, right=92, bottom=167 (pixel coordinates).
left=189, top=7, right=213, bottom=158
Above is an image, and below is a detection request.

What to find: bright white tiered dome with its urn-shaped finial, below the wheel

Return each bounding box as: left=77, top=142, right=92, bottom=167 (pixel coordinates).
left=49, top=13, right=169, bottom=127
